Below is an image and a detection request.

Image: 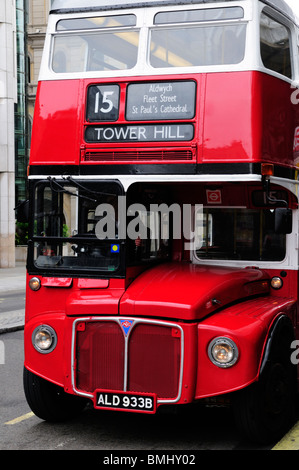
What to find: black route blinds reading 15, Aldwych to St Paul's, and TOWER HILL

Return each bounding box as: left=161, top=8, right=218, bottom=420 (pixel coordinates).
left=85, top=80, right=196, bottom=143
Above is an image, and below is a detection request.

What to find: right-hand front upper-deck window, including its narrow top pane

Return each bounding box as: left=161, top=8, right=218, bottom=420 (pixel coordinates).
left=150, top=7, right=246, bottom=68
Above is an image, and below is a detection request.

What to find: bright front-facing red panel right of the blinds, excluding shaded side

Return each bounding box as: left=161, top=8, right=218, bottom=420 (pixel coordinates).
left=203, top=72, right=261, bottom=163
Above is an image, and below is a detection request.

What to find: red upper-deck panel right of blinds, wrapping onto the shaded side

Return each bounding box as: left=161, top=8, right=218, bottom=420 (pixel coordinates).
left=203, top=72, right=299, bottom=166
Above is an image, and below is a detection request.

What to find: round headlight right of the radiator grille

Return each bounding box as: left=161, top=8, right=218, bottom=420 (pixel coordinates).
left=208, top=338, right=239, bottom=368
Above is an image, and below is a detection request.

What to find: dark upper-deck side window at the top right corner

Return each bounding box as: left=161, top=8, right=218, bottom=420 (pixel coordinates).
left=260, top=12, right=292, bottom=78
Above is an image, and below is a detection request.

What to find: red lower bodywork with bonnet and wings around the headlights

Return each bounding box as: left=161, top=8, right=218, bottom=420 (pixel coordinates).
left=25, top=263, right=296, bottom=403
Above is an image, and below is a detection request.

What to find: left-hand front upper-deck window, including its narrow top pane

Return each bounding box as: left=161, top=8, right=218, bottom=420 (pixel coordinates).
left=52, top=15, right=139, bottom=73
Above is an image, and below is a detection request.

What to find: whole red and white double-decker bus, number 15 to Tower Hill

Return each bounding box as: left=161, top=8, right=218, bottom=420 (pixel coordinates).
left=24, top=0, right=299, bottom=442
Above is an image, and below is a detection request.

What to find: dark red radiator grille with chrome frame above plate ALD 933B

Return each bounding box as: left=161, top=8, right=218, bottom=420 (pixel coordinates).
left=75, top=318, right=183, bottom=401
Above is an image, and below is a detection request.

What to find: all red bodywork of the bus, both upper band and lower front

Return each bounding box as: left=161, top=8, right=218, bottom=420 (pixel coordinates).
left=25, top=71, right=299, bottom=410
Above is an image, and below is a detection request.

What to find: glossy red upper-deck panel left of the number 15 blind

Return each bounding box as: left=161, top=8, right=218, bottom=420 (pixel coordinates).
left=30, top=80, right=82, bottom=165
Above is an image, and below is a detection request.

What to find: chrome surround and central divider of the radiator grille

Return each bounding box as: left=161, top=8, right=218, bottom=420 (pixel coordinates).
left=71, top=316, right=185, bottom=404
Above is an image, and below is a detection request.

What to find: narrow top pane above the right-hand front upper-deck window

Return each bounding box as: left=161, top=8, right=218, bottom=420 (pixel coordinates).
left=154, top=7, right=244, bottom=24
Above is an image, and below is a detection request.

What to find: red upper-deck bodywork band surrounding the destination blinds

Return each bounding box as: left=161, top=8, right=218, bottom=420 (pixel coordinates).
left=30, top=72, right=299, bottom=172
